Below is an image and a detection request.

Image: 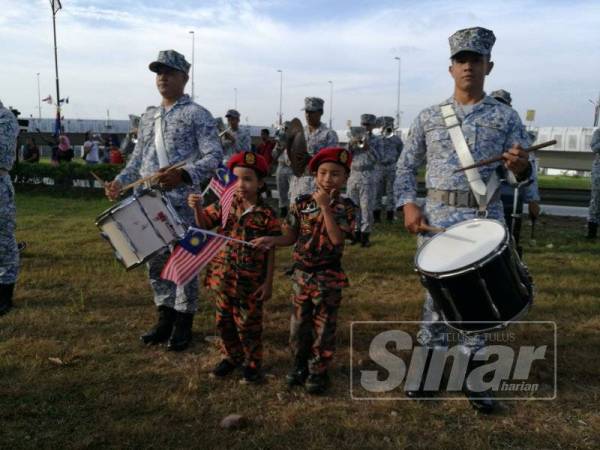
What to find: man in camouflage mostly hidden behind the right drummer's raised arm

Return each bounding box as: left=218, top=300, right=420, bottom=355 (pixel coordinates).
left=490, top=89, right=540, bottom=256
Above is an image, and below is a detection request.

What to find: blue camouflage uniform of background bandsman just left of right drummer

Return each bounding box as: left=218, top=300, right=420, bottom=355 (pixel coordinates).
left=375, top=134, right=404, bottom=211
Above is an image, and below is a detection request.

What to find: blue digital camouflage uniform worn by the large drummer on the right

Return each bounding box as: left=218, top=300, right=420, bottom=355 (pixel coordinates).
left=394, top=96, right=528, bottom=348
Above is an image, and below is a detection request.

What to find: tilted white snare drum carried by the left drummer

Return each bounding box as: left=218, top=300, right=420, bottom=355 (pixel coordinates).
left=96, top=190, right=186, bottom=270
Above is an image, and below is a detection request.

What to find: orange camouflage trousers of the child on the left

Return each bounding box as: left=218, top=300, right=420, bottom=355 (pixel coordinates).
left=216, top=292, right=263, bottom=368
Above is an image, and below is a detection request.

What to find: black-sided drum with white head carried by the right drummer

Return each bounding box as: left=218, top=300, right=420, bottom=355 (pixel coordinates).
left=415, top=219, right=533, bottom=334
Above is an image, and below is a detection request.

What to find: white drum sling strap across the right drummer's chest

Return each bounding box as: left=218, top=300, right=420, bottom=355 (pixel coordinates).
left=441, top=105, right=500, bottom=214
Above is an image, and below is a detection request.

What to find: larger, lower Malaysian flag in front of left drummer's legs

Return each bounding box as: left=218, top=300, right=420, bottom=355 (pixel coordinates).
left=160, top=227, right=228, bottom=286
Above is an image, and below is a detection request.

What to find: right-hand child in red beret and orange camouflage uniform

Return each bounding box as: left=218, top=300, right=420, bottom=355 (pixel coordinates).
left=253, top=147, right=356, bottom=394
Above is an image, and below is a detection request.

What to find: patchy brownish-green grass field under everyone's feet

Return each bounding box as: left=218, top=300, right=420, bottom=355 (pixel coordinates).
left=0, top=185, right=600, bottom=449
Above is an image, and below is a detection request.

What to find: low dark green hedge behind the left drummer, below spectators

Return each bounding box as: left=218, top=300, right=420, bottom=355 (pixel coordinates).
left=10, top=162, right=123, bottom=186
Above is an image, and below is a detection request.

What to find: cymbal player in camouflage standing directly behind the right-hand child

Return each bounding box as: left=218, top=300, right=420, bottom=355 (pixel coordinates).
left=290, top=97, right=338, bottom=202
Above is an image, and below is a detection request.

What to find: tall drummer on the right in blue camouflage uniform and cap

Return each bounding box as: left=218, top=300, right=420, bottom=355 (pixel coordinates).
left=394, top=27, right=531, bottom=412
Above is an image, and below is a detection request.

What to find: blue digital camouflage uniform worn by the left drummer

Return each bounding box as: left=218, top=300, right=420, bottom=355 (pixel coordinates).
left=116, top=95, right=223, bottom=313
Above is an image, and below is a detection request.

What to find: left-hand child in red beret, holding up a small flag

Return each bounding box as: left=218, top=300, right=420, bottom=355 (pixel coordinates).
left=188, top=152, right=281, bottom=383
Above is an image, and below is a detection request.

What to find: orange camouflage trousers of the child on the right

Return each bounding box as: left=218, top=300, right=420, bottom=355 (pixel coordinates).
left=290, top=269, right=348, bottom=374
